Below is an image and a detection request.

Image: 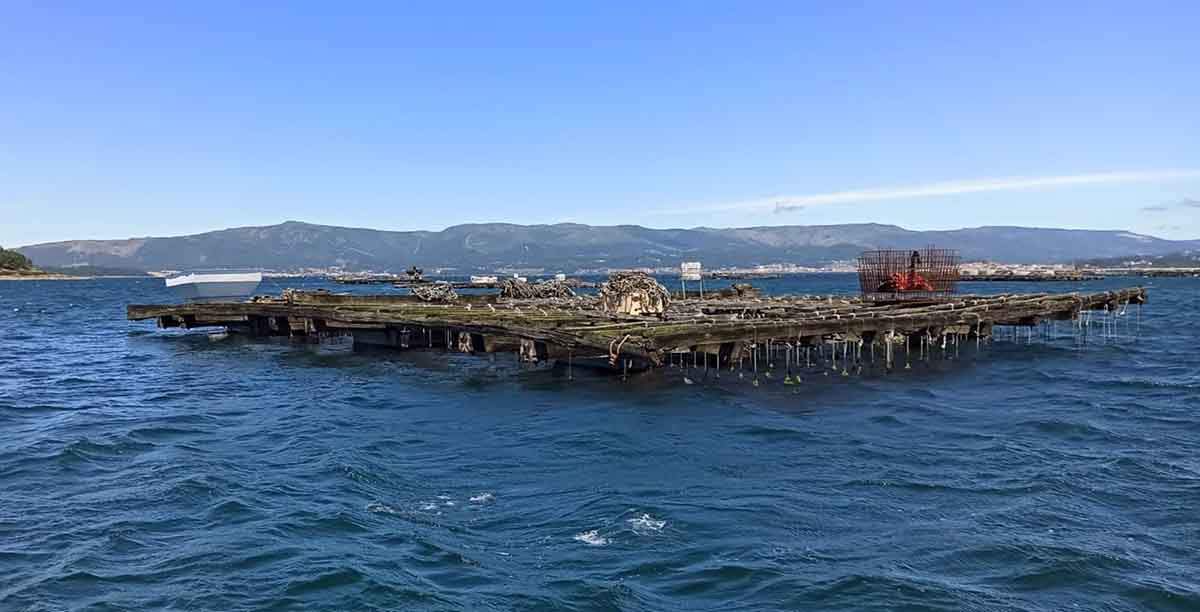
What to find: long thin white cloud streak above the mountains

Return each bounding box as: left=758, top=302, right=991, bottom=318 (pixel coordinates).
left=661, top=169, right=1200, bottom=212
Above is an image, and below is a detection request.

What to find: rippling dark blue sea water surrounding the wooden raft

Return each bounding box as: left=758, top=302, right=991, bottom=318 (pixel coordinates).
left=0, top=275, right=1200, bottom=611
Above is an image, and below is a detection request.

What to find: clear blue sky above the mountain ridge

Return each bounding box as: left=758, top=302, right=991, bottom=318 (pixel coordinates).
left=0, top=1, right=1200, bottom=246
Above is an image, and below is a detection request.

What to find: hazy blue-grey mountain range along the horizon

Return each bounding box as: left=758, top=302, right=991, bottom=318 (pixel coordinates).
left=18, top=221, right=1200, bottom=272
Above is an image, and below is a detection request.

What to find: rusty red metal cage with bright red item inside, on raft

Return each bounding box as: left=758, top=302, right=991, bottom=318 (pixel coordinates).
left=858, top=248, right=959, bottom=300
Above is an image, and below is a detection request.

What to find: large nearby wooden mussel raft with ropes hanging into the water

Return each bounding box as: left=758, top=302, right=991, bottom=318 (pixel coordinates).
left=127, top=287, right=1146, bottom=372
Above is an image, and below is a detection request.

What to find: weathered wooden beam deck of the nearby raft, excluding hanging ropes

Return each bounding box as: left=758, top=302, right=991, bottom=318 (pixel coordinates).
left=126, top=288, right=1146, bottom=365
